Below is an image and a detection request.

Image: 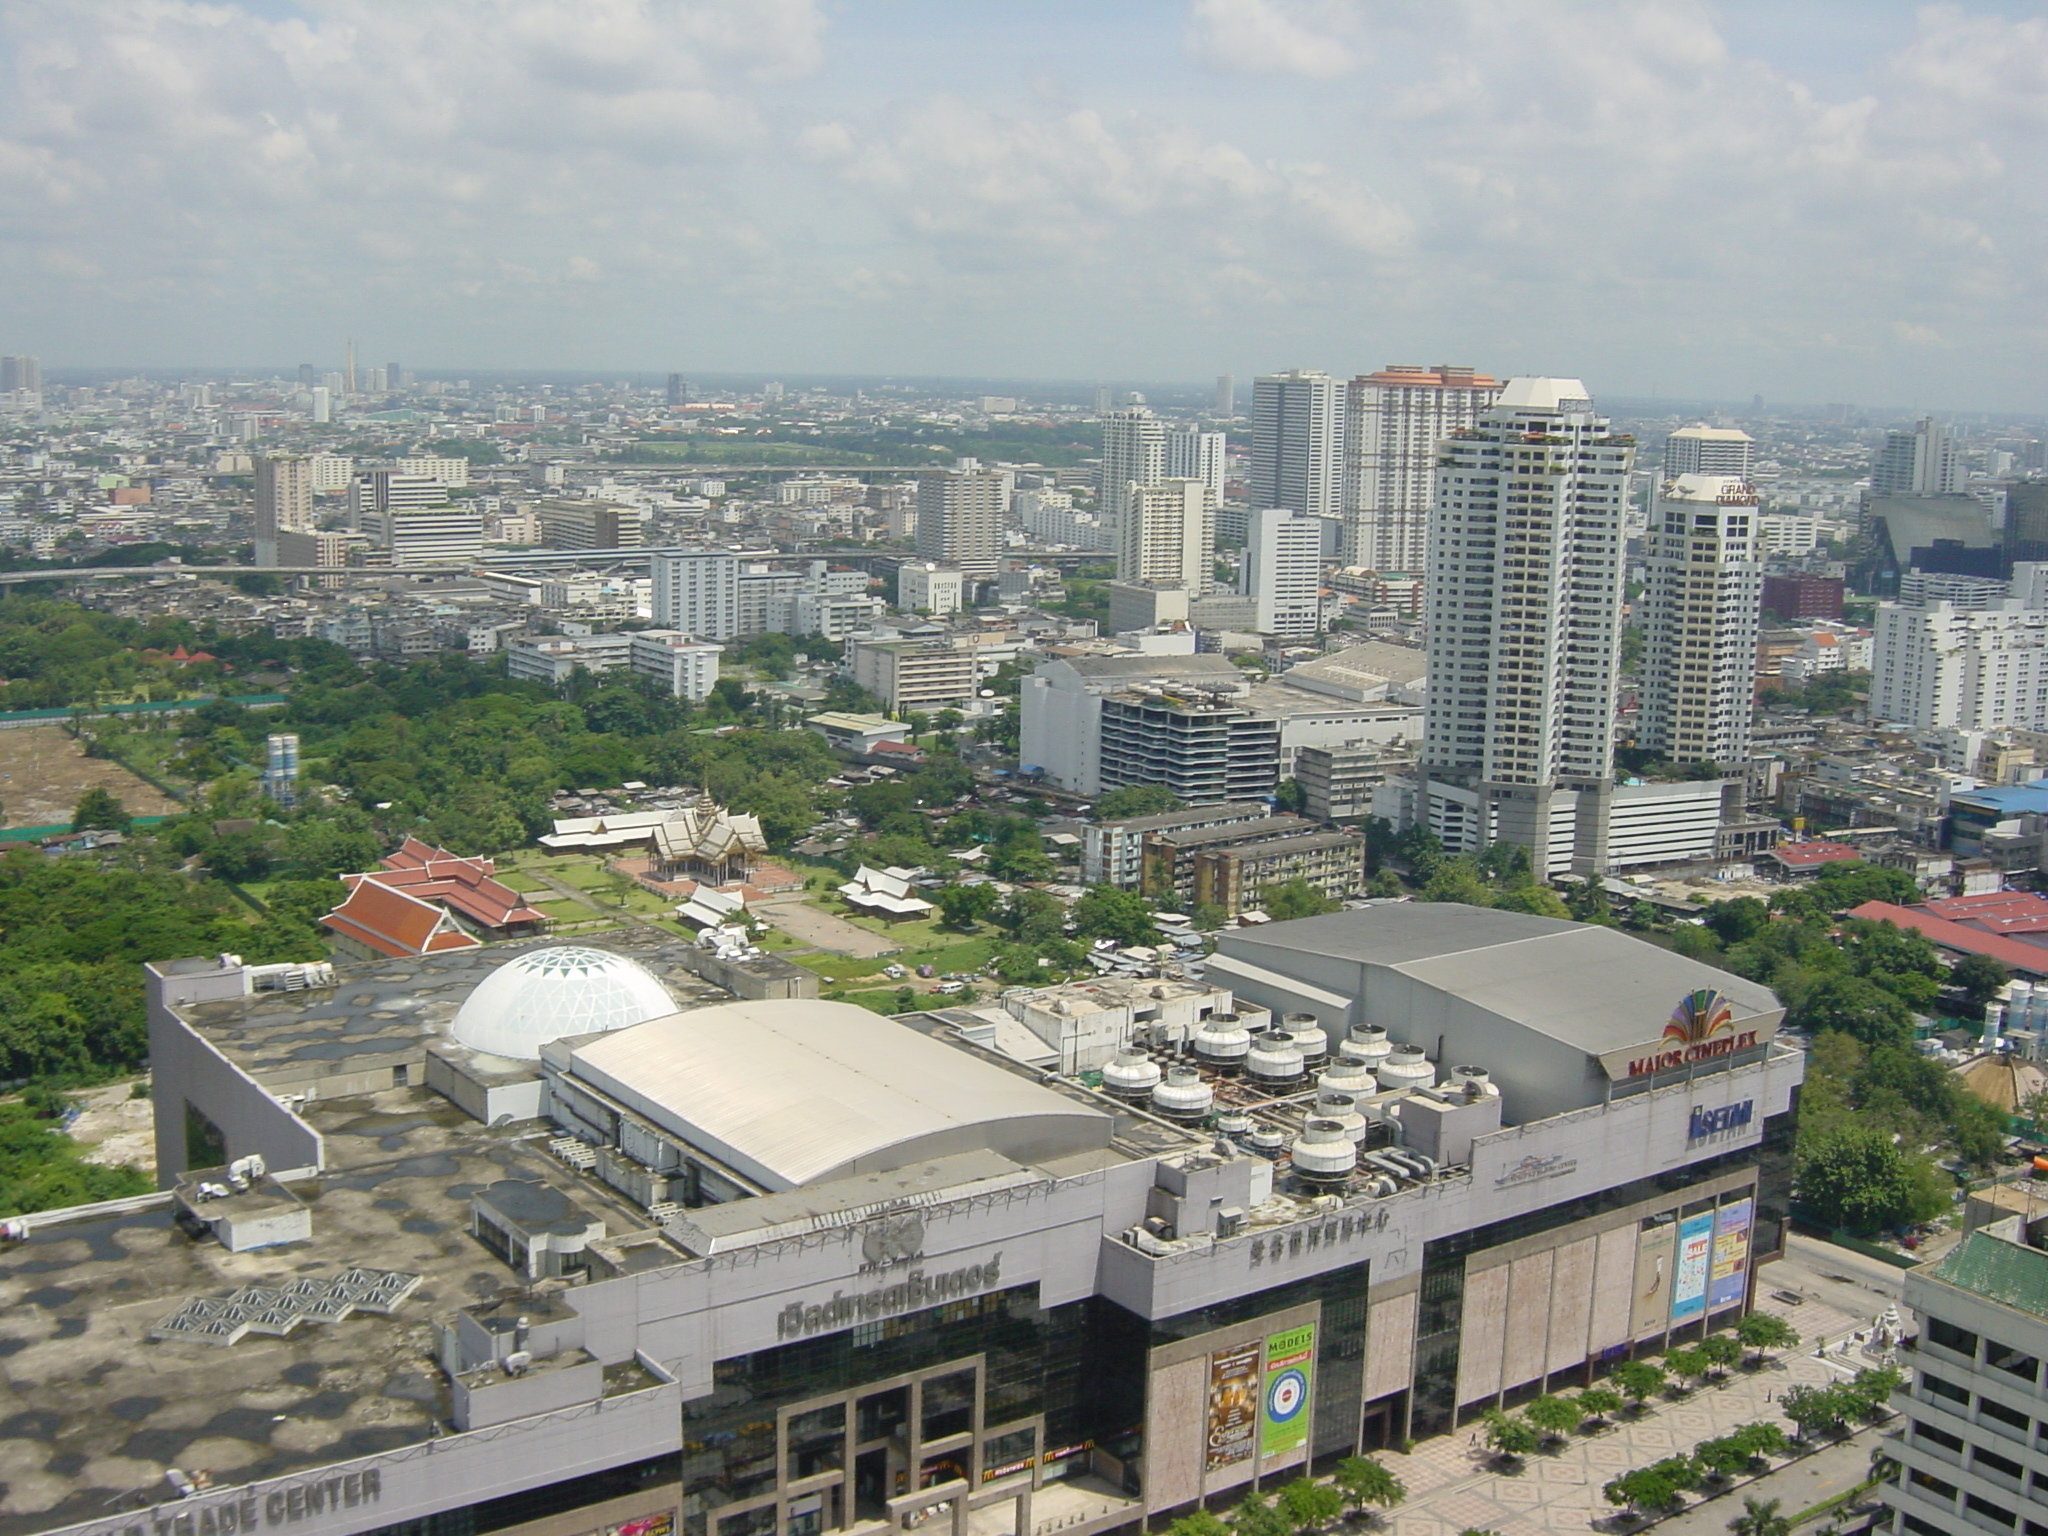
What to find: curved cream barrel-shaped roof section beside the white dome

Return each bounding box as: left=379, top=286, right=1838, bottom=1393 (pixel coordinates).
left=551, top=999, right=1114, bottom=1190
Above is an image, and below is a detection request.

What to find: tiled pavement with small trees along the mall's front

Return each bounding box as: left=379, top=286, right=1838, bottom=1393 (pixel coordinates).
left=1378, top=1298, right=1874, bottom=1536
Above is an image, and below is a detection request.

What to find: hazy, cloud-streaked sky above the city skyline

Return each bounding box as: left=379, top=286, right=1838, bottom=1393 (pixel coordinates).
left=0, top=0, right=2048, bottom=410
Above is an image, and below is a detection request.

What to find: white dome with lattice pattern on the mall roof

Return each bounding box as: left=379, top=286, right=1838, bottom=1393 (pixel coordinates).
left=449, top=944, right=676, bottom=1061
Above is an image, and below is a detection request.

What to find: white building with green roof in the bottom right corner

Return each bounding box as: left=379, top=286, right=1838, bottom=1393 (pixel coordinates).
left=1884, top=1212, right=2048, bottom=1536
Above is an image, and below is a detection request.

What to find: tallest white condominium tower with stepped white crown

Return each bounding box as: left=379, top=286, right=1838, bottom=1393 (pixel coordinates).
left=1417, top=379, right=1634, bottom=879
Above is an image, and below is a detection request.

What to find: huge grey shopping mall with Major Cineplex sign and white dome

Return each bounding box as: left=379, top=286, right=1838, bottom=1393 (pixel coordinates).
left=0, top=903, right=1761, bottom=1536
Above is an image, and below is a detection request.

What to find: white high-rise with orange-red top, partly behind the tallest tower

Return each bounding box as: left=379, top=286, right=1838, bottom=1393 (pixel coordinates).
left=1343, top=362, right=1501, bottom=571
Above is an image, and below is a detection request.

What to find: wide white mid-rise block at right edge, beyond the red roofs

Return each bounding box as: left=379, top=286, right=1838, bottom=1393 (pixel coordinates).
left=1870, top=563, right=2048, bottom=731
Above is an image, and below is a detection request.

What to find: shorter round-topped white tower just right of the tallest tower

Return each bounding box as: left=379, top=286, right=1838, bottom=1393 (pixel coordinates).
left=1636, top=475, right=1763, bottom=768
